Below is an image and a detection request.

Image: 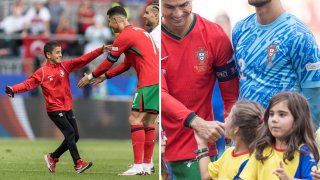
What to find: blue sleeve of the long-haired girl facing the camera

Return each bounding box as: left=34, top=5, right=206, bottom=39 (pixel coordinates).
left=294, top=145, right=318, bottom=180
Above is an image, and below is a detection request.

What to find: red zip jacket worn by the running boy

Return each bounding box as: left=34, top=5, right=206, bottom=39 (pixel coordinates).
left=12, top=48, right=102, bottom=112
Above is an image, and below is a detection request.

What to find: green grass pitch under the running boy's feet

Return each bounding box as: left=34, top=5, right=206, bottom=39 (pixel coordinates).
left=0, top=138, right=159, bottom=180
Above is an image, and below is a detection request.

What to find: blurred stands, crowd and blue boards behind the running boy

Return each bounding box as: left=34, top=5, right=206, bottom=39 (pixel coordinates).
left=0, top=0, right=153, bottom=139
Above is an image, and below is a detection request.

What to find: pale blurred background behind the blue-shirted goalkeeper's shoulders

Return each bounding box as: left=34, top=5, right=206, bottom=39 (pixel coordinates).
left=193, top=0, right=320, bottom=44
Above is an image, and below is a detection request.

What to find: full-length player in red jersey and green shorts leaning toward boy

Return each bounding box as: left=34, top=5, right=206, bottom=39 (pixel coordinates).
left=78, top=6, right=159, bottom=176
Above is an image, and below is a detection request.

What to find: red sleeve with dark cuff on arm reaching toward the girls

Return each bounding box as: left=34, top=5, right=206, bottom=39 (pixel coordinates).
left=161, top=75, right=195, bottom=126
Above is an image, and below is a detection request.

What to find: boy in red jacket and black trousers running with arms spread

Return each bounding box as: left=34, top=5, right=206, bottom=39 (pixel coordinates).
left=5, top=41, right=108, bottom=173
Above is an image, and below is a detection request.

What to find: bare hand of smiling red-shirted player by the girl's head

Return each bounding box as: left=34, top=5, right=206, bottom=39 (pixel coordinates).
left=191, top=116, right=224, bottom=142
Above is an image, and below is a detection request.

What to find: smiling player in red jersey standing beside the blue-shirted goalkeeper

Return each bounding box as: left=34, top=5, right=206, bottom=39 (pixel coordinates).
left=161, top=0, right=239, bottom=179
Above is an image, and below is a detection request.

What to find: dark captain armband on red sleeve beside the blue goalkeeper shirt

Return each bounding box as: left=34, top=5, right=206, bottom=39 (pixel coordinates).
left=213, top=58, right=238, bottom=82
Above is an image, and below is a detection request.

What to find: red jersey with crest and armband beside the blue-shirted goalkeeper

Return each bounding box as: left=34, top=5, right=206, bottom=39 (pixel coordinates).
left=161, top=14, right=239, bottom=161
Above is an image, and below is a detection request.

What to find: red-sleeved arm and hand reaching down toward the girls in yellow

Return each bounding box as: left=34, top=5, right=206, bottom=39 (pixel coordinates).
left=161, top=75, right=224, bottom=142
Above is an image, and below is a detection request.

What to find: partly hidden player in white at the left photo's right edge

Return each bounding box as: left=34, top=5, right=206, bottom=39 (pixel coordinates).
left=143, top=3, right=161, bottom=48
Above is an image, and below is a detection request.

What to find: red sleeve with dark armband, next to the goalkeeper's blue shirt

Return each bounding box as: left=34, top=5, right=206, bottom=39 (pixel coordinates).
left=213, top=29, right=239, bottom=117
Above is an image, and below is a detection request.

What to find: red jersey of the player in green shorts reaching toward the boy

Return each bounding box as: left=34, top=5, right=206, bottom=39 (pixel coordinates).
left=92, top=26, right=159, bottom=88
